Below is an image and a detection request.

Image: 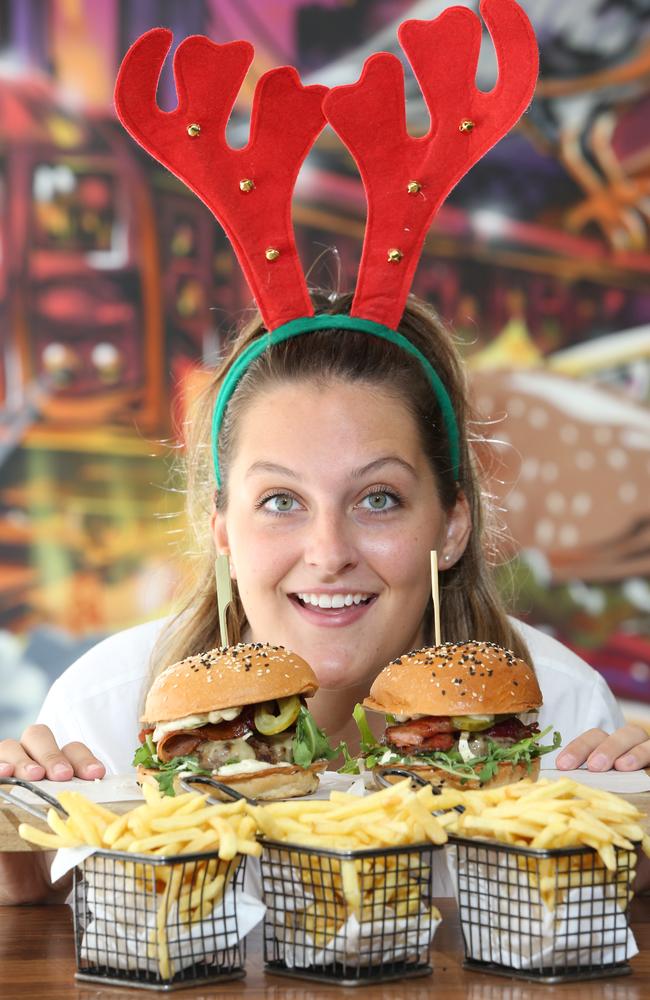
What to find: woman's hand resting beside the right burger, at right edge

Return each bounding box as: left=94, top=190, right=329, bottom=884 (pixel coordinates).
left=555, top=725, right=650, bottom=771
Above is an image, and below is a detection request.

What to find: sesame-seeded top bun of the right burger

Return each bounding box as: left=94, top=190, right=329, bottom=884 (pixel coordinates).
left=363, top=641, right=542, bottom=717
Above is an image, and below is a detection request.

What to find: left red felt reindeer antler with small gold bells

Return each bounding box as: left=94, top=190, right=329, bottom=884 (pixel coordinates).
left=115, top=28, right=327, bottom=329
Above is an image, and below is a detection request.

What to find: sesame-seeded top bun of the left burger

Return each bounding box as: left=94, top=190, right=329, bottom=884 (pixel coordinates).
left=140, top=642, right=318, bottom=722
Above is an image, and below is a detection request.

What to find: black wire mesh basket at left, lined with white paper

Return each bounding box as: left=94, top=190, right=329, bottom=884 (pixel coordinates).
left=74, top=851, right=245, bottom=990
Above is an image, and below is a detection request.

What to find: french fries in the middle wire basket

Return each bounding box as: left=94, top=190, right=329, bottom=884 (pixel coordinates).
left=249, top=779, right=447, bottom=948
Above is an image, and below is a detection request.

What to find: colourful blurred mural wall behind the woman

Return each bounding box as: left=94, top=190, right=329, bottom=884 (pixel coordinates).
left=0, top=0, right=650, bottom=737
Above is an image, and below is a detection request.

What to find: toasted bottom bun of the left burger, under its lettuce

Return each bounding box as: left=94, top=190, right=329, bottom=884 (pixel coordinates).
left=136, top=760, right=327, bottom=802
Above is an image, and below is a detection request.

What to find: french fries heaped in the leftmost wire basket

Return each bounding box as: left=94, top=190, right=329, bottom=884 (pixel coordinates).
left=18, top=784, right=262, bottom=979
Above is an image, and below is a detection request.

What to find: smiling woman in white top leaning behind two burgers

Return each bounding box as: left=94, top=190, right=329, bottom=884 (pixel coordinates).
left=0, top=296, right=650, bottom=899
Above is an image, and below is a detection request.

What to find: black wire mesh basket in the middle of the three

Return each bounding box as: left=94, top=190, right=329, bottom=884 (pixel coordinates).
left=261, top=839, right=440, bottom=986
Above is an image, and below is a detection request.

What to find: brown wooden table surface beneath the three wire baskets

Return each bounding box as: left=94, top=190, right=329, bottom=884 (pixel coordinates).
left=0, top=896, right=650, bottom=1000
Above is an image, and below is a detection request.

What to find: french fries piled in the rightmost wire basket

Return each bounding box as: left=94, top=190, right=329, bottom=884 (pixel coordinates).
left=436, top=778, right=650, bottom=911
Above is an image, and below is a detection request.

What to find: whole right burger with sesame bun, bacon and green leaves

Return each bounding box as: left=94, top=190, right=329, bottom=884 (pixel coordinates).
left=354, top=642, right=560, bottom=789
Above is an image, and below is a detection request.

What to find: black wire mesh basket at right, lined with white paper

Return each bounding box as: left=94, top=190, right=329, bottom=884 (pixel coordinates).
left=447, top=836, right=636, bottom=983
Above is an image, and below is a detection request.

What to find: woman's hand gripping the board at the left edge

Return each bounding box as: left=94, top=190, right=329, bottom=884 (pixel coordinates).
left=0, top=725, right=106, bottom=781
